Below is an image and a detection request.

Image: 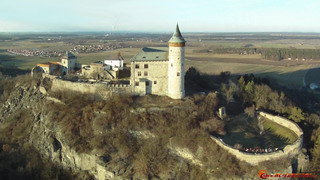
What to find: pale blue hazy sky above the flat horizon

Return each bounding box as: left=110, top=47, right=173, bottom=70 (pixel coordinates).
left=0, top=0, right=320, bottom=32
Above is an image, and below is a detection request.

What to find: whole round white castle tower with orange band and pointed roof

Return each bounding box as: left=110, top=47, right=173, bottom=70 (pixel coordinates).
left=168, top=25, right=186, bottom=99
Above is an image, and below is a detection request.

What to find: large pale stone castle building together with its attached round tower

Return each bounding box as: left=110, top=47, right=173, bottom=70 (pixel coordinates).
left=130, top=25, right=186, bottom=99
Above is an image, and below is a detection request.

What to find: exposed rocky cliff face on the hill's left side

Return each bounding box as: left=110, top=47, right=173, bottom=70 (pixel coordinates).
left=0, top=80, right=115, bottom=180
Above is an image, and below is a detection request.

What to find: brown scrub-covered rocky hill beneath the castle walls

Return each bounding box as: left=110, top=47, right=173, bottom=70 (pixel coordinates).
left=0, top=68, right=319, bottom=179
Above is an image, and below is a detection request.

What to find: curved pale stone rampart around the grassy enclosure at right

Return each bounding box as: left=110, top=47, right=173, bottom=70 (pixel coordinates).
left=211, top=112, right=303, bottom=165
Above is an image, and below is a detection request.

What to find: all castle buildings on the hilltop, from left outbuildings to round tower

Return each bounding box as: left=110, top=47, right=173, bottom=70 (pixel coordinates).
left=32, top=25, right=186, bottom=99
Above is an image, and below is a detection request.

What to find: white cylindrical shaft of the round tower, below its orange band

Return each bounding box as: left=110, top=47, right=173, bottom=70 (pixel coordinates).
left=168, top=46, right=185, bottom=99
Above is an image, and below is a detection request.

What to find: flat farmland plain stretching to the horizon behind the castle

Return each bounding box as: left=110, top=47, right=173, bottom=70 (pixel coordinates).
left=0, top=33, right=320, bottom=87
